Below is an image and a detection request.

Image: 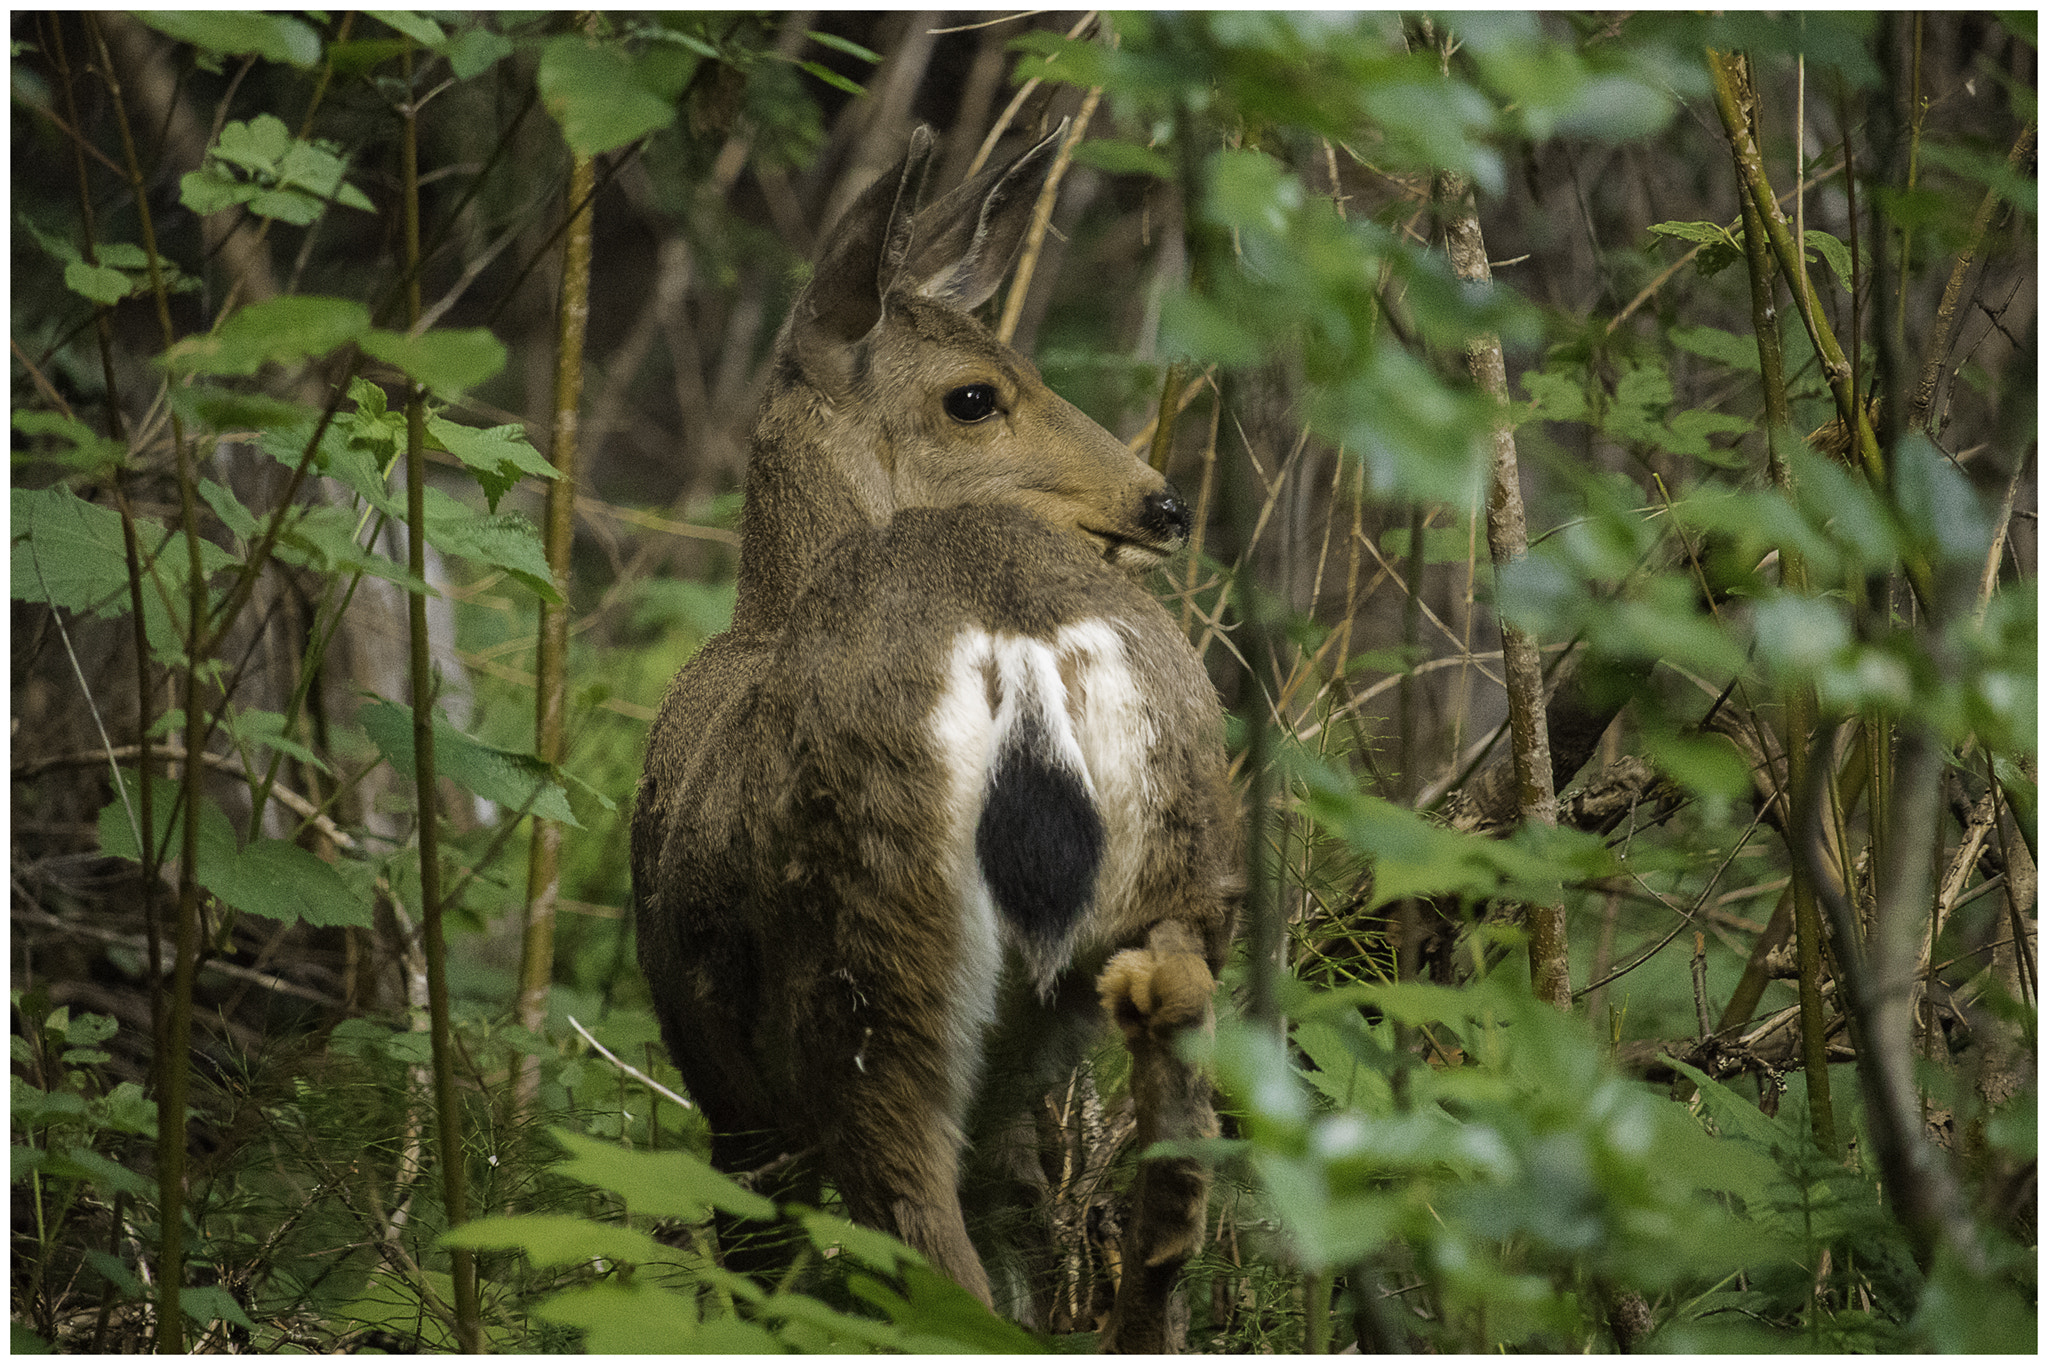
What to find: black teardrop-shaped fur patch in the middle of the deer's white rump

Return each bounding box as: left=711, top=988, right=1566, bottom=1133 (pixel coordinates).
left=975, top=714, right=1104, bottom=948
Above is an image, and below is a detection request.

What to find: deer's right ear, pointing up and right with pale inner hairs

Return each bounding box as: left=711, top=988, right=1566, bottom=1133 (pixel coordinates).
left=893, top=119, right=1067, bottom=311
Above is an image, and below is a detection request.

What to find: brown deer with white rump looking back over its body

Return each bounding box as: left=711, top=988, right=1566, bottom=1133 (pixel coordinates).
left=631, top=129, right=1243, bottom=1351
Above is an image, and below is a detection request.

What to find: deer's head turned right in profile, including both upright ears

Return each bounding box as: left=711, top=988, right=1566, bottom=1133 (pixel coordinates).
left=778, top=129, right=1190, bottom=573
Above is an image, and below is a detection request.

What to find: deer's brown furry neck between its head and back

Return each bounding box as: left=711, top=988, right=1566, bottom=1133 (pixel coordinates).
left=733, top=392, right=891, bottom=634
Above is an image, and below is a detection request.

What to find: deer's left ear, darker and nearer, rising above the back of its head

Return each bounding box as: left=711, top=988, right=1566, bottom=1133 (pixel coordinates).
left=791, top=127, right=932, bottom=383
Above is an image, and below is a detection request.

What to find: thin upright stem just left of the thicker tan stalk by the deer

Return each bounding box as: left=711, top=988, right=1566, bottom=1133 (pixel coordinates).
left=401, top=39, right=481, bottom=1355
